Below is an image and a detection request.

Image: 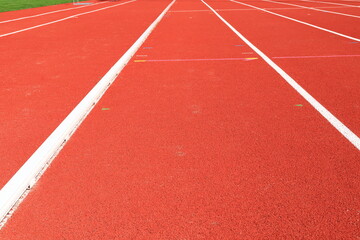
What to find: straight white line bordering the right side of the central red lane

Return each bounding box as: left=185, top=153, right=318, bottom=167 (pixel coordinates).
left=201, top=0, right=360, bottom=150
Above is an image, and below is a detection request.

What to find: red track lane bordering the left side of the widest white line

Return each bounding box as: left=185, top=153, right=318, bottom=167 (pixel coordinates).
left=0, top=1, right=170, bottom=190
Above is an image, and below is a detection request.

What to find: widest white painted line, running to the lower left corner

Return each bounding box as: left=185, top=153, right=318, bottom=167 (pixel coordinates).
left=0, top=0, right=176, bottom=227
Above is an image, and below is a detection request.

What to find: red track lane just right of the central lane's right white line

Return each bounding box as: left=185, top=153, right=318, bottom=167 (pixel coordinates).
left=210, top=1, right=360, bottom=135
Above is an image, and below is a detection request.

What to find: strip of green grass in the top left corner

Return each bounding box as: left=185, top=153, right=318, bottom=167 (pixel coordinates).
left=0, top=0, right=78, bottom=12
